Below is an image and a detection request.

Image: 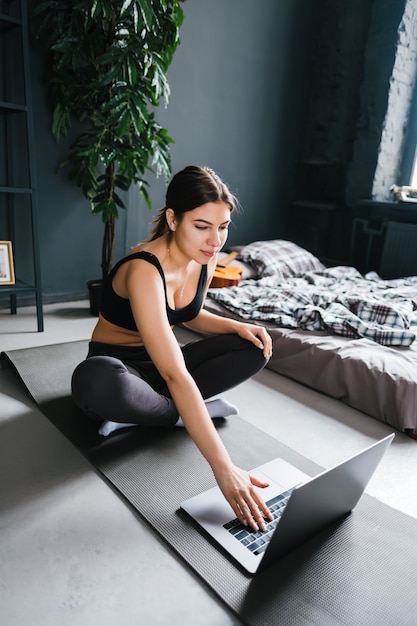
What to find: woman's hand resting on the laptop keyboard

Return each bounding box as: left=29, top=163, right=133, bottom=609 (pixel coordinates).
left=213, top=465, right=273, bottom=530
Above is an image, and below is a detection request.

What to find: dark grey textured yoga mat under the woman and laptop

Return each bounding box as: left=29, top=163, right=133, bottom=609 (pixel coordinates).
left=2, top=342, right=417, bottom=626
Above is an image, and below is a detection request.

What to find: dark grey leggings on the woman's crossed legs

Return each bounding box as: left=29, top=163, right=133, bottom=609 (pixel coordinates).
left=72, top=334, right=267, bottom=426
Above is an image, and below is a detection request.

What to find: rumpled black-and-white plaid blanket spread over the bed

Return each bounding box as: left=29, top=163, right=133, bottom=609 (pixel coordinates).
left=209, top=266, right=417, bottom=347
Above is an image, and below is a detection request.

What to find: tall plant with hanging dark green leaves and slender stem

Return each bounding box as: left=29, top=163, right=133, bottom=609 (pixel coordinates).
left=30, top=0, right=184, bottom=314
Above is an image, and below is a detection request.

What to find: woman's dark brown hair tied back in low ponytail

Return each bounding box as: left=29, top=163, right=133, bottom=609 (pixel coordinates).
left=149, top=165, right=238, bottom=241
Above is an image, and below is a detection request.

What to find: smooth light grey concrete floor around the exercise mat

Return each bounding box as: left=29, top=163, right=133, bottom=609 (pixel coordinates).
left=0, top=302, right=417, bottom=626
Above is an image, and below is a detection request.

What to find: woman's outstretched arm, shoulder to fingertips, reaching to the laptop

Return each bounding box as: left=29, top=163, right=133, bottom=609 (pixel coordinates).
left=126, top=261, right=270, bottom=528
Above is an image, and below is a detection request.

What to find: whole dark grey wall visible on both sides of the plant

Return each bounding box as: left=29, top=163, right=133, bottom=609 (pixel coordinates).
left=19, top=0, right=314, bottom=302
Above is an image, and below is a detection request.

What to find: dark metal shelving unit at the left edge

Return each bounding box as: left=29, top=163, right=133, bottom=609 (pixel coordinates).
left=0, top=0, right=43, bottom=332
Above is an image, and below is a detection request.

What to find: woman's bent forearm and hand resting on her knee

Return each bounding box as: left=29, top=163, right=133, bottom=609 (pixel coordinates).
left=184, top=309, right=272, bottom=358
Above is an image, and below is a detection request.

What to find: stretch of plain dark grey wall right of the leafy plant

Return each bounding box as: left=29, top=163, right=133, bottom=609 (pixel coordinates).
left=142, top=0, right=312, bottom=243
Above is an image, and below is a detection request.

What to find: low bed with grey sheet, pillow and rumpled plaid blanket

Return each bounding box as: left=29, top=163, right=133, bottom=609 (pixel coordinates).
left=205, top=240, right=417, bottom=437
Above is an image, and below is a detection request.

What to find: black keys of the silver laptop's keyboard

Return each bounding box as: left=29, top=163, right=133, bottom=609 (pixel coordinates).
left=223, top=487, right=295, bottom=554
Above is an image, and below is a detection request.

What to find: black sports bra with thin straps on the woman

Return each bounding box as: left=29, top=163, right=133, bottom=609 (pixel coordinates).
left=100, top=250, right=207, bottom=331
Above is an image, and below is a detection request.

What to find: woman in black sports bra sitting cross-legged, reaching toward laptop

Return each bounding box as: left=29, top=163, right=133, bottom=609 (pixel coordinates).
left=72, top=166, right=272, bottom=530
